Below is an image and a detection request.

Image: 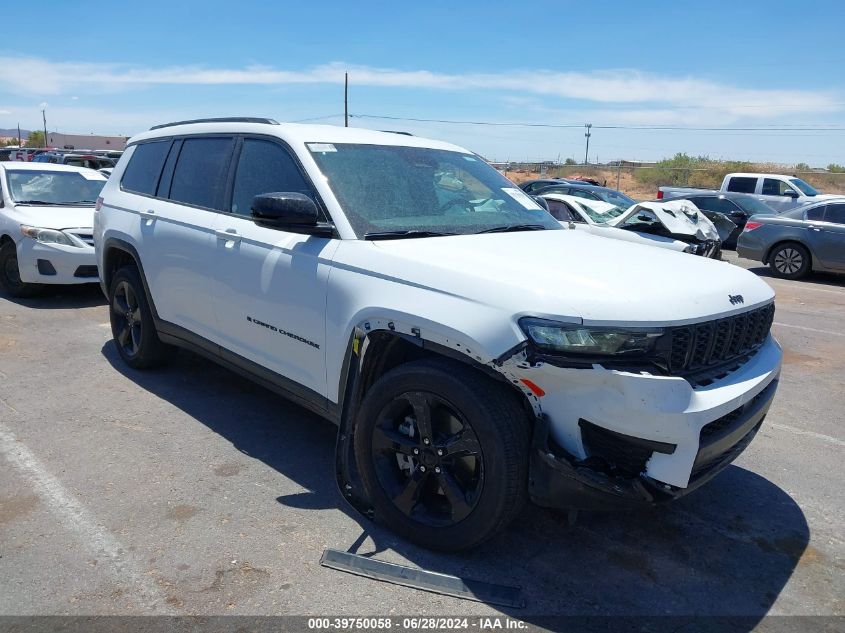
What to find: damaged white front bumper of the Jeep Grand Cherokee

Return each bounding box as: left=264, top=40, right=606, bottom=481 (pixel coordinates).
left=516, top=337, right=780, bottom=510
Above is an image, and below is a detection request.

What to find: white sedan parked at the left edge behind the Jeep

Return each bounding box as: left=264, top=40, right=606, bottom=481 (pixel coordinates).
left=0, top=162, right=106, bottom=297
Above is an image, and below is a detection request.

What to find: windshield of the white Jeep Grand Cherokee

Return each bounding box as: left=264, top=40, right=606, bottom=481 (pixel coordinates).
left=308, top=143, right=562, bottom=237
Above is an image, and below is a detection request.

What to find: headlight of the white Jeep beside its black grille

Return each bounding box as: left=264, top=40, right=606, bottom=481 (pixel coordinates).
left=519, top=317, right=663, bottom=356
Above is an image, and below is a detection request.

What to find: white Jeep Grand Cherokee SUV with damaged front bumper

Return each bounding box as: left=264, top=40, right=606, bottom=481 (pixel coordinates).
left=94, top=119, right=781, bottom=549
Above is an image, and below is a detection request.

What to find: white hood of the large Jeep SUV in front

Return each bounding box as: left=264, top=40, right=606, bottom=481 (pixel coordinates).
left=348, top=230, right=774, bottom=325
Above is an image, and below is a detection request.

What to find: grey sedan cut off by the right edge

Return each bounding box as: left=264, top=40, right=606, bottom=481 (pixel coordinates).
left=736, top=197, right=845, bottom=279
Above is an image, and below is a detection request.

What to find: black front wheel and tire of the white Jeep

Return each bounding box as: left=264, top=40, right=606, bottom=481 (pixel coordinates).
left=355, top=359, right=529, bottom=551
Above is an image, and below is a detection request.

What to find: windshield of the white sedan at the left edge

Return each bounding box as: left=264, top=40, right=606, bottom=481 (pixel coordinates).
left=6, top=169, right=106, bottom=205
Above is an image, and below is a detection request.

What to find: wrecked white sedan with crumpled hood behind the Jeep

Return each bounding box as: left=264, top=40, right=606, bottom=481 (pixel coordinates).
left=541, top=193, right=721, bottom=258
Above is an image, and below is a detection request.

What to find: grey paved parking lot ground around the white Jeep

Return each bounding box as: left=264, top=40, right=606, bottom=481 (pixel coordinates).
left=0, top=253, right=845, bottom=628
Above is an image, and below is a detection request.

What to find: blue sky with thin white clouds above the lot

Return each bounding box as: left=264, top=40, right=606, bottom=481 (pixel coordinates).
left=0, top=0, right=845, bottom=166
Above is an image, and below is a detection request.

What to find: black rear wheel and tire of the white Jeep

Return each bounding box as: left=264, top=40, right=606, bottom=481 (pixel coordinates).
left=109, top=266, right=173, bottom=369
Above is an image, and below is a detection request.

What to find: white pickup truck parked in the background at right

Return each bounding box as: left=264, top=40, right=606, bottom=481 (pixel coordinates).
left=657, top=173, right=837, bottom=213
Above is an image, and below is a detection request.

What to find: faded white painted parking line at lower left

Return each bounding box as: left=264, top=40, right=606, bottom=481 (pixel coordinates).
left=0, top=422, right=175, bottom=615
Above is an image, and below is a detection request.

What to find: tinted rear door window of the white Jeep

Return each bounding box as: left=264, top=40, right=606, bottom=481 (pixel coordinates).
left=170, top=138, right=233, bottom=210
